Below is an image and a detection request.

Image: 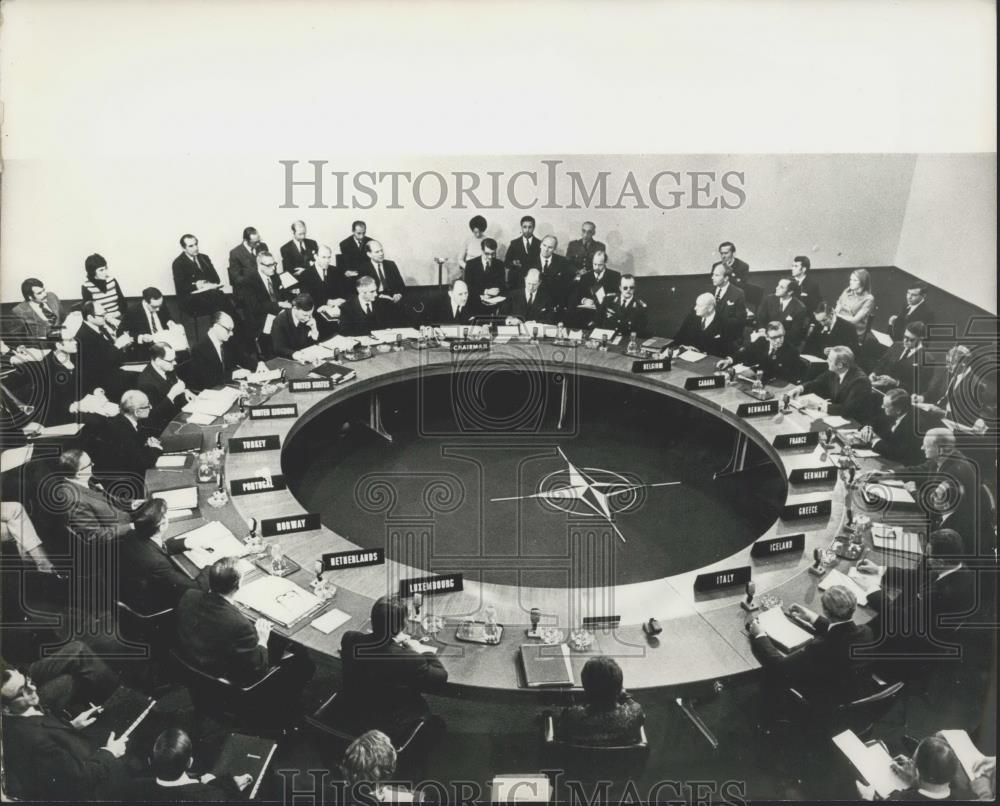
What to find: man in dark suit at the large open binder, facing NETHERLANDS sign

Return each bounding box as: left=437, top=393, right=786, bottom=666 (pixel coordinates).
left=177, top=557, right=313, bottom=692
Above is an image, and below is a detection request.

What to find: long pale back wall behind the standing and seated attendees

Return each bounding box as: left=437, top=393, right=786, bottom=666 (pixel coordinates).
left=0, top=155, right=915, bottom=301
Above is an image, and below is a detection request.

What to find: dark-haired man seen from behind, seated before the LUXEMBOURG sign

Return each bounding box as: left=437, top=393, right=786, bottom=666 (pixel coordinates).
left=340, top=596, right=448, bottom=743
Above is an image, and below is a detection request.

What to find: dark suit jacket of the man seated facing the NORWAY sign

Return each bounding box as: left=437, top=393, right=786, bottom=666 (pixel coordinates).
left=118, top=534, right=198, bottom=614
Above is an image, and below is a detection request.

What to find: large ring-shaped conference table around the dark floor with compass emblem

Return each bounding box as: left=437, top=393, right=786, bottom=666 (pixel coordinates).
left=146, top=341, right=900, bottom=696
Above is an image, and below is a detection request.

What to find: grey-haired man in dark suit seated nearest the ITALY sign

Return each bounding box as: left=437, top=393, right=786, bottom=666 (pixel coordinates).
left=747, top=585, right=872, bottom=710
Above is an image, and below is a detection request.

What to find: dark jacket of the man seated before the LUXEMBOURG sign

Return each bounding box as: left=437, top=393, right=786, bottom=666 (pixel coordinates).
left=340, top=630, right=448, bottom=736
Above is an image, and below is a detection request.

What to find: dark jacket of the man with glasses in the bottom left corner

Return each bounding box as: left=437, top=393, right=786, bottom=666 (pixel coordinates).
left=3, top=714, right=125, bottom=802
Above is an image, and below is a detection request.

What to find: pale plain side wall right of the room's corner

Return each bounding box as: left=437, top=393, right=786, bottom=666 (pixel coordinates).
left=892, top=154, right=997, bottom=314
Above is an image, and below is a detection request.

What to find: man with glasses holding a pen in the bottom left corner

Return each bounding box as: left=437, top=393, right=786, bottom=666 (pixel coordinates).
left=0, top=666, right=128, bottom=801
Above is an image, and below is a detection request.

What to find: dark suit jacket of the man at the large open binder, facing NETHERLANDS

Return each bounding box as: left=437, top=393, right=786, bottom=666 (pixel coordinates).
left=177, top=588, right=269, bottom=686
